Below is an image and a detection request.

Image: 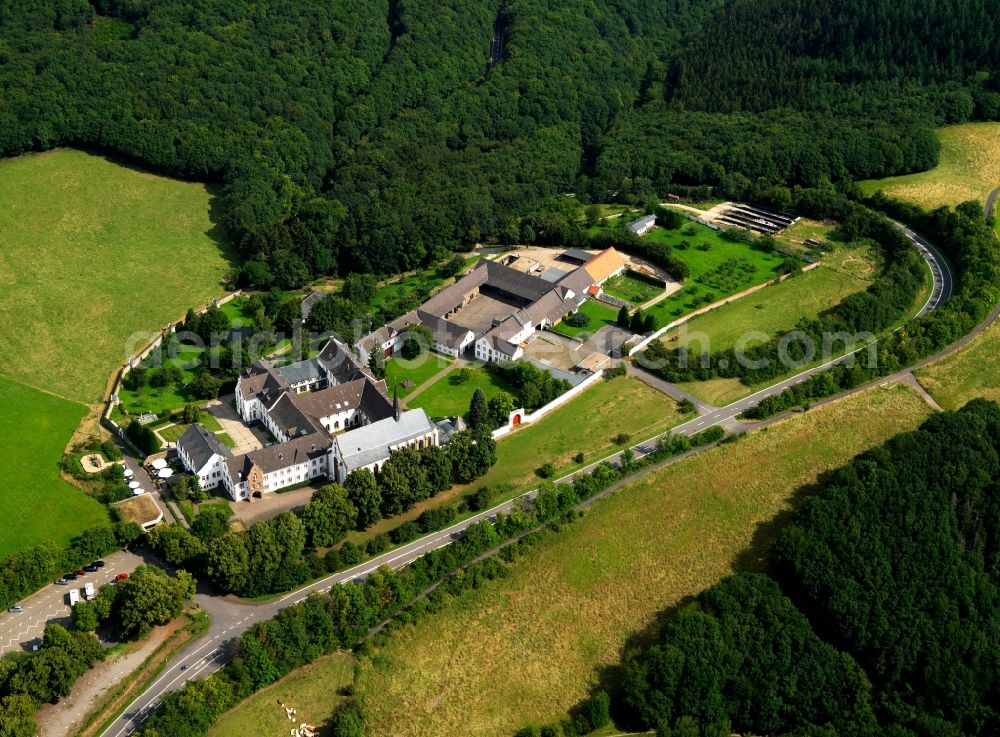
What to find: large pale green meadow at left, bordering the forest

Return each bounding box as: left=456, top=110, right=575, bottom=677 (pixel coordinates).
left=0, top=149, right=228, bottom=403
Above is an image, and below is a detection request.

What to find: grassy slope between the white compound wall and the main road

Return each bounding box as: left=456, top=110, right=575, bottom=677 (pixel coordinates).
left=350, top=376, right=691, bottom=542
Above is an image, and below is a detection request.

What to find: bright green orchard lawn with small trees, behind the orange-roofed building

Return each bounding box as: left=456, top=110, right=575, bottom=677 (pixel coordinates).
left=643, top=223, right=785, bottom=327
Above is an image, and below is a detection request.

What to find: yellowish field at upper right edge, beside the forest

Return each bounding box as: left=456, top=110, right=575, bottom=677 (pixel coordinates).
left=860, top=123, right=1000, bottom=209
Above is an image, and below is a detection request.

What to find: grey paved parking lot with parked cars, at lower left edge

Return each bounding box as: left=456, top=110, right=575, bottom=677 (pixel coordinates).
left=0, top=552, right=148, bottom=655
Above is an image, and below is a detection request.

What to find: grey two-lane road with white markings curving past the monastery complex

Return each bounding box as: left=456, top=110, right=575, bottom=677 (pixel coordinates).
left=102, top=223, right=956, bottom=737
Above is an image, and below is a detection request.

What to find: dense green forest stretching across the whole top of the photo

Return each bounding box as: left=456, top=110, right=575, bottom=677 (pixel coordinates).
left=0, top=0, right=1000, bottom=288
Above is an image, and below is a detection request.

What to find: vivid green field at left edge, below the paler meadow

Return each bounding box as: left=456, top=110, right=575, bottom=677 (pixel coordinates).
left=0, top=376, right=109, bottom=557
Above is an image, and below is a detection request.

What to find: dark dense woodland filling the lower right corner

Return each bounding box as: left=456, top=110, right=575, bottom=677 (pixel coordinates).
left=613, top=400, right=1000, bottom=737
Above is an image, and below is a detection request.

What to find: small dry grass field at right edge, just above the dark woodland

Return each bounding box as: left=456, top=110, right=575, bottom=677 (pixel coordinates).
left=917, top=321, right=1000, bottom=410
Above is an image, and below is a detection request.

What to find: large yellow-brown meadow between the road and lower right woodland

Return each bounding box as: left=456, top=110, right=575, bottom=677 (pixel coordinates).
left=357, top=386, right=929, bottom=737
